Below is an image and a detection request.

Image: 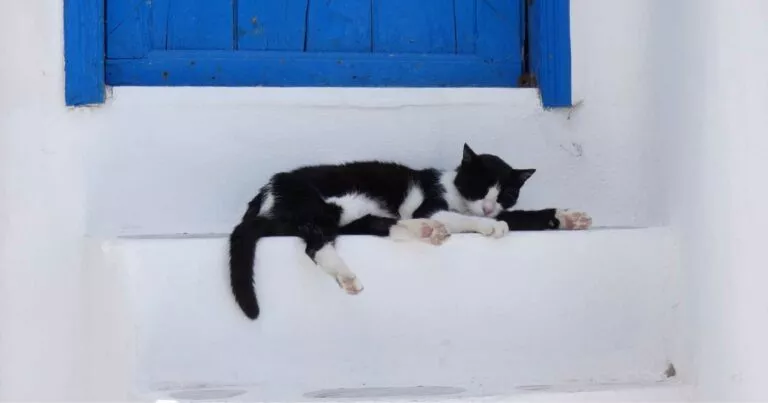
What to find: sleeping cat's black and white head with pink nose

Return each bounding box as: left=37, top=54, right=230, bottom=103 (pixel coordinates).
left=454, top=144, right=536, bottom=217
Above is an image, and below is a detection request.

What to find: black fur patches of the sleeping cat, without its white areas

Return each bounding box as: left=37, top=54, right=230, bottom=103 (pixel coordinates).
left=229, top=145, right=544, bottom=319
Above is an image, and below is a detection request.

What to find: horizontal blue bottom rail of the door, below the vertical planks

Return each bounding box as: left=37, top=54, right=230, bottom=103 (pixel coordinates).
left=107, top=51, right=521, bottom=87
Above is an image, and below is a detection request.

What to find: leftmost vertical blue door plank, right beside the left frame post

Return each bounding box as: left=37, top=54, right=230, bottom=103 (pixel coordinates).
left=107, top=0, right=150, bottom=59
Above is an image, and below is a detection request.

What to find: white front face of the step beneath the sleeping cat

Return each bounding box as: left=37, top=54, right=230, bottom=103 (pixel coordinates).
left=93, top=228, right=677, bottom=401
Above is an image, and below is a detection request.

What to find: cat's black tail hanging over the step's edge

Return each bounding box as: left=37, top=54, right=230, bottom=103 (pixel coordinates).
left=229, top=217, right=276, bottom=319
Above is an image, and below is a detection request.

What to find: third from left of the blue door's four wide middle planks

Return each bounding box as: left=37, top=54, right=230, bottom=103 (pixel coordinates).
left=307, top=0, right=371, bottom=52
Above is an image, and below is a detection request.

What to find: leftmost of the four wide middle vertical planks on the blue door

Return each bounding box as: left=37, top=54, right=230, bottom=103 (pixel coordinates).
left=169, top=0, right=236, bottom=50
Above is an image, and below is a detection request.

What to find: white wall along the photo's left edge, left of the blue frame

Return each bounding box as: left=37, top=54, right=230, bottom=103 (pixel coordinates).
left=0, top=1, right=90, bottom=401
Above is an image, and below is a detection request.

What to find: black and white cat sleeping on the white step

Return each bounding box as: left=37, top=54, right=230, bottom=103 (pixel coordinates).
left=229, top=144, right=591, bottom=319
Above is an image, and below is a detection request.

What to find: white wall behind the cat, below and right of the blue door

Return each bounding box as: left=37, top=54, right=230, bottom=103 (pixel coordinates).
left=85, top=1, right=665, bottom=235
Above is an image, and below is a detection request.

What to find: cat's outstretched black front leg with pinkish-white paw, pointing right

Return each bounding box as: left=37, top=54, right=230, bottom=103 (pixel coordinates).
left=496, top=208, right=592, bottom=231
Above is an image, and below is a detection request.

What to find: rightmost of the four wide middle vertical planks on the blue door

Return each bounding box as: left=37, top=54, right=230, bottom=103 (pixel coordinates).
left=373, top=0, right=456, bottom=53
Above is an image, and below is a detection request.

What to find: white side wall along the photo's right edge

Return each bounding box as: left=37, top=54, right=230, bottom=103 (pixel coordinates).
left=653, top=0, right=768, bottom=401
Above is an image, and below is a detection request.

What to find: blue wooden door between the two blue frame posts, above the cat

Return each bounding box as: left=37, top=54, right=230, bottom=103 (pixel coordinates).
left=106, top=0, right=525, bottom=87
